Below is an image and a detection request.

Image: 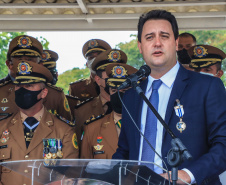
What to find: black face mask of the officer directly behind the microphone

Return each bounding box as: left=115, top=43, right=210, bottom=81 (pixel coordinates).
left=110, top=92, right=124, bottom=114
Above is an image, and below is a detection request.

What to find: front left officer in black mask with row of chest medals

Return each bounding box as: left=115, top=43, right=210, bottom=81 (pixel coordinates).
left=0, top=60, right=79, bottom=185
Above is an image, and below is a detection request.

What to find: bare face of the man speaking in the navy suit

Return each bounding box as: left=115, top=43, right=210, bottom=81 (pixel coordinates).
left=138, top=20, right=178, bottom=72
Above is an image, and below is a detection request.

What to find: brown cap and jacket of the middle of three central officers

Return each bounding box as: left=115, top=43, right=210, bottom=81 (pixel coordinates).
left=74, top=49, right=127, bottom=147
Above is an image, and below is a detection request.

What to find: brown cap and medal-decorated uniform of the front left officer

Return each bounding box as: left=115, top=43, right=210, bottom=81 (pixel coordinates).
left=0, top=61, right=78, bottom=185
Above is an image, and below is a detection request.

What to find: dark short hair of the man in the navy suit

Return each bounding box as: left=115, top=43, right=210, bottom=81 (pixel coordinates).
left=138, top=10, right=179, bottom=42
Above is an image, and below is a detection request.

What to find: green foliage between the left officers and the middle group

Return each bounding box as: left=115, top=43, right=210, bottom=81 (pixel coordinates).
left=56, top=67, right=90, bottom=94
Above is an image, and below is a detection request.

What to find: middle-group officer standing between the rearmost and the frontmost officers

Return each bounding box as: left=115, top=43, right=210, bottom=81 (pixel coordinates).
left=74, top=49, right=127, bottom=149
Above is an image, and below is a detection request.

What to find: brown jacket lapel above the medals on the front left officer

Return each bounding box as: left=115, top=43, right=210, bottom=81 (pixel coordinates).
left=27, top=110, right=53, bottom=153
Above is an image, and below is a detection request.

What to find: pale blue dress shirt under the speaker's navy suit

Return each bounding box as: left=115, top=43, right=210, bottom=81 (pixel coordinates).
left=139, top=62, right=194, bottom=181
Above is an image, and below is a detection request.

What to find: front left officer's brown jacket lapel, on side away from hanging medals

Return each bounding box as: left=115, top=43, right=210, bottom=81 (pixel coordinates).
left=9, top=112, right=26, bottom=151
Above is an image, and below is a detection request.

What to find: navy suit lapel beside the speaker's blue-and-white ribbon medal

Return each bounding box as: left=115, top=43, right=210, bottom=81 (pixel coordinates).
left=163, top=66, right=189, bottom=135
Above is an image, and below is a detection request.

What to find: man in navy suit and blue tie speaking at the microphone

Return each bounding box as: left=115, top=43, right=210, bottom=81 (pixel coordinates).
left=113, top=10, right=226, bottom=185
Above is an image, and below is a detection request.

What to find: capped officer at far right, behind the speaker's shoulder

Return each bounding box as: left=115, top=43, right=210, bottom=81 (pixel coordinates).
left=188, top=45, right=226, bottom=78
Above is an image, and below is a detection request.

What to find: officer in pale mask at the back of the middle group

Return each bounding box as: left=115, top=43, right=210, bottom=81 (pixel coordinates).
left=69, top=39, right=111, bottom=100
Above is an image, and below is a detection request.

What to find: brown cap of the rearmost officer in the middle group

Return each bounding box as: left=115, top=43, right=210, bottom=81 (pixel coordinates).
left=82, top=39, right=111, bottom=58
